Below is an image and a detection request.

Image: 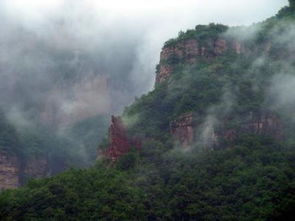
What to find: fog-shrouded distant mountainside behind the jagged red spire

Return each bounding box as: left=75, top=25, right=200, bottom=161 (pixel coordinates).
left=0, top=2, right=162, bottom=180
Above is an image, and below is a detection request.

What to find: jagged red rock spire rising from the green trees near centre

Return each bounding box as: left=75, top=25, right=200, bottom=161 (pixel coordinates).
left=105, top=116, right=140, bottom=161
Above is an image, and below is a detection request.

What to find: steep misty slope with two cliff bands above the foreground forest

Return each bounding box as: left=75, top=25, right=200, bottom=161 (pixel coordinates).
left=123, top=8, right=294, bottom=152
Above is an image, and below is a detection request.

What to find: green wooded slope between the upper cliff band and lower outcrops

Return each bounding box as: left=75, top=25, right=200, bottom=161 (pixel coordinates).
left=123, top=49, right=266, bottom=146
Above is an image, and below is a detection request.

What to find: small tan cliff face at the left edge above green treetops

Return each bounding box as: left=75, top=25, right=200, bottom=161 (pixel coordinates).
left=0, top=153, right=19, bottom=190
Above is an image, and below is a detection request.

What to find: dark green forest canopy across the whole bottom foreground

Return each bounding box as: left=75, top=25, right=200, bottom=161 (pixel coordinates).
left=0, top=137, right=295, bottom=220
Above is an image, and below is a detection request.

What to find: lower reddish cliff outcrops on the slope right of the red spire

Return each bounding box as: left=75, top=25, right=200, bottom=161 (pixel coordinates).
left=170, top=112, right=284, bottom=147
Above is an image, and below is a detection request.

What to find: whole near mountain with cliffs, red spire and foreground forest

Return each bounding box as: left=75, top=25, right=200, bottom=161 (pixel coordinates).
left=0, top=1, right=295, bottom=220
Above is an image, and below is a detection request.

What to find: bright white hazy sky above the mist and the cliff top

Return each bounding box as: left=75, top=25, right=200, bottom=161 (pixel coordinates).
left=1, top=0, right=288, bottom=87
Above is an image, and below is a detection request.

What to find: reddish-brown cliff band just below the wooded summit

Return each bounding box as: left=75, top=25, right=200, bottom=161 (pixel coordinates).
left=156, top=37, right=245, bottom=85
